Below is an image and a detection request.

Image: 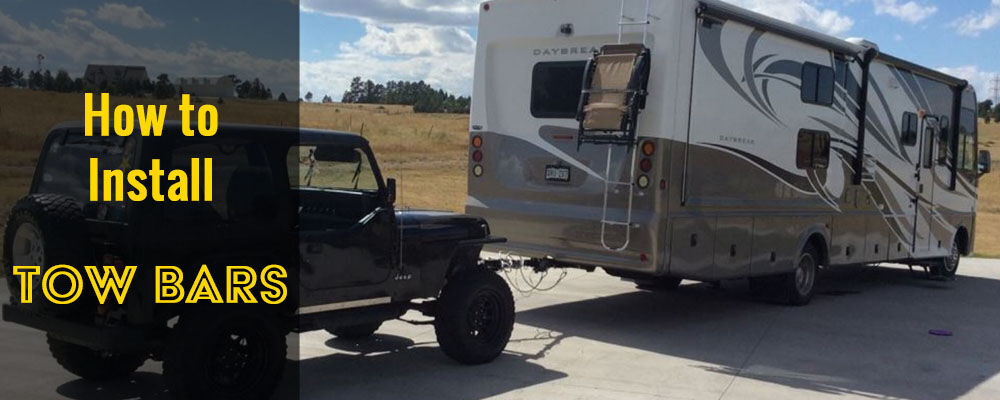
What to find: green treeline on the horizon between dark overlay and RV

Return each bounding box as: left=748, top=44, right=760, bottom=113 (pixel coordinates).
left=341, top=76, right=470, bottom=114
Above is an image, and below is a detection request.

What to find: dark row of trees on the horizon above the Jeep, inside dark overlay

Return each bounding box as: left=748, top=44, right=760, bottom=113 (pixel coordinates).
left=0, top=65, right=285, bottom=101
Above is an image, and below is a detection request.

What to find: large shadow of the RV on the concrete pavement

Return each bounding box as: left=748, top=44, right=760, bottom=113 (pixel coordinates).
left=517, top=267, right=1000, bottom=400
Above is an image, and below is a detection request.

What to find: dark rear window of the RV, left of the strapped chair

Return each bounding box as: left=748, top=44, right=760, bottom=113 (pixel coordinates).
left=531, top=61, right=587, bottom=118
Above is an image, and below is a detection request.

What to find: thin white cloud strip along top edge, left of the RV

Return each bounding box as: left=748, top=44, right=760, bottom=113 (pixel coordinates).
left=299, top=0, right=482, bottom=26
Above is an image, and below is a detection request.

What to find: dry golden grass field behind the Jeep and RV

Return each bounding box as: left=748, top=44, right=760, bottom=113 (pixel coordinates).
left=0, top=88, right=1000, bottom=264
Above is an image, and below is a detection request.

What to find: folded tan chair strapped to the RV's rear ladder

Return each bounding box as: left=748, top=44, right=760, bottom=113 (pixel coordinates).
left=576, top=43, right=650, bottom=145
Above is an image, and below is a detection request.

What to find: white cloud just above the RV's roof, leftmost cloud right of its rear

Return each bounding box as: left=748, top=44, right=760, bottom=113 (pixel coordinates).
left=725, top=0, right=854, bottom=35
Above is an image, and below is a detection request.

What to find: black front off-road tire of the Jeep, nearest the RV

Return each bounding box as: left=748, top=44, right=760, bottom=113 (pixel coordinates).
left=434, top=268, right=514, bottom=365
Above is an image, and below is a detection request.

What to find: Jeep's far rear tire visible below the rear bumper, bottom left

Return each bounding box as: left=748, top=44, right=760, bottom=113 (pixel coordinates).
left=47, top=334, right=147, bottom=381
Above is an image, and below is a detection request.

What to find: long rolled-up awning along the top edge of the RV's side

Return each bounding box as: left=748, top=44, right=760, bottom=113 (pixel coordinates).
left=699, top=0, right=967, bottom=86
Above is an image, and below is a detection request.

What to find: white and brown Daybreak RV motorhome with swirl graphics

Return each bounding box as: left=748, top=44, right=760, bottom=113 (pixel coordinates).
left=466, top=0, right=989, bottom=304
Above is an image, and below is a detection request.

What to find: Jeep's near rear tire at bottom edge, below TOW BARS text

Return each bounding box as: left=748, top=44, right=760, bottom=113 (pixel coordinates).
left=163, top=307, right=288, bottom=400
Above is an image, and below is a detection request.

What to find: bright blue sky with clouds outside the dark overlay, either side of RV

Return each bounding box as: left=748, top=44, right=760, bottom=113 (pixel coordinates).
left=300, top=0, right=1000, bottom=98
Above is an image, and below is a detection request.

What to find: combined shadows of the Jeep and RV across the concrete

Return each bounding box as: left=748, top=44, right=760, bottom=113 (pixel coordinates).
left=23, top=267, right=1000, bottom=400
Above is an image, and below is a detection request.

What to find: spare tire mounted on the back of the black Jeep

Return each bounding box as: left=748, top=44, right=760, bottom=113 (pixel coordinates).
left=3, top=194, right=87, bottom=315
